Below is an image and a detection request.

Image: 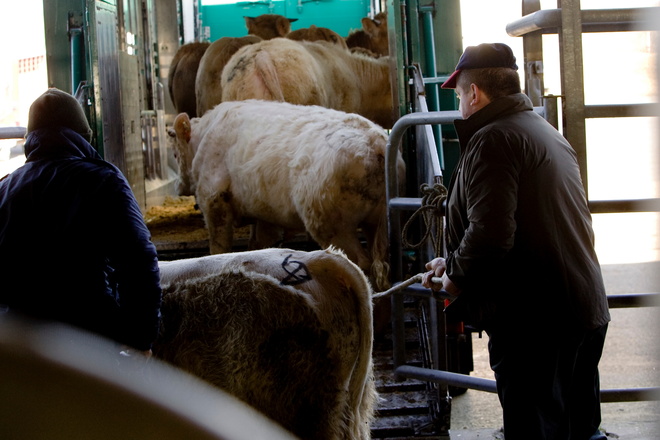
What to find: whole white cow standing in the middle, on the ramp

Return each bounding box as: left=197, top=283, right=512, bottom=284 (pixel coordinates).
left=168, top=100, right=405, bottom=290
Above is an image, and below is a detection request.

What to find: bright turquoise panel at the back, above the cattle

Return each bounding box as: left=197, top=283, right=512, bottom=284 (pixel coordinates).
left=201, top=0, right=369, bottom=41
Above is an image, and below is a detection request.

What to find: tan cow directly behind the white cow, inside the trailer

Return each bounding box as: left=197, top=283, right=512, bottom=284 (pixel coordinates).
left=222, top=38, right=394, bottom=128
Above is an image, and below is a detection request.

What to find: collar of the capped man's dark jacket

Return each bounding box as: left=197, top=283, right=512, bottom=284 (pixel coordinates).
left=454, top=93, right=534, bottom=148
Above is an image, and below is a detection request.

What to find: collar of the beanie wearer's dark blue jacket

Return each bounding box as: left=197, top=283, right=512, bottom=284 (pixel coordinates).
left=25, top=127, right=102, bottom=162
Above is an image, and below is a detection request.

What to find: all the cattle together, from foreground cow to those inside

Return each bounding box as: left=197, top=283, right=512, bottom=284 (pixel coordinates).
left=161, top=13, right=398, bottom=440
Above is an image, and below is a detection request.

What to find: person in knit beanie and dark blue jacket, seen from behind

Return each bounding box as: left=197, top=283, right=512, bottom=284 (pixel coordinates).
left=0, top=88, right=161, bottom=355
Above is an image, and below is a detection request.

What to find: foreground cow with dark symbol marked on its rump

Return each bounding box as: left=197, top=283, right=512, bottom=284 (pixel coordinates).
left=153, top=249, right=377, bottom=440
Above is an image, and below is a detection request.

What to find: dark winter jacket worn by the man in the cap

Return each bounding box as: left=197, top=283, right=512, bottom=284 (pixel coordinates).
left=446, top=94, right=610, bottom=330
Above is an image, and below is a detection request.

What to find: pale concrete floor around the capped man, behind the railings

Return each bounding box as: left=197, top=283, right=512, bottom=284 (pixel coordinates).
left=450, top=262, right=660, bottom=440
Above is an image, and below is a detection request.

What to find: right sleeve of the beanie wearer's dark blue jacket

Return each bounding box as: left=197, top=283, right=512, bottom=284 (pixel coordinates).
left=105, top=170, right=161, bottom=350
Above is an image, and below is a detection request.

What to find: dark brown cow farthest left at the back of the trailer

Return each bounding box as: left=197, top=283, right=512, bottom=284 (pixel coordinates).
left=167, top=42, right=210, bottom=118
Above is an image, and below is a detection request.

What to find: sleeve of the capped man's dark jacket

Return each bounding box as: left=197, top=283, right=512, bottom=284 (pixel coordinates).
left=447, top=131, right=520, bottom=289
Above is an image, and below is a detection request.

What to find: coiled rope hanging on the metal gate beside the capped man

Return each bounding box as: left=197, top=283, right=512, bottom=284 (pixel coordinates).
left=401, top=183, right=447, bottom=255
